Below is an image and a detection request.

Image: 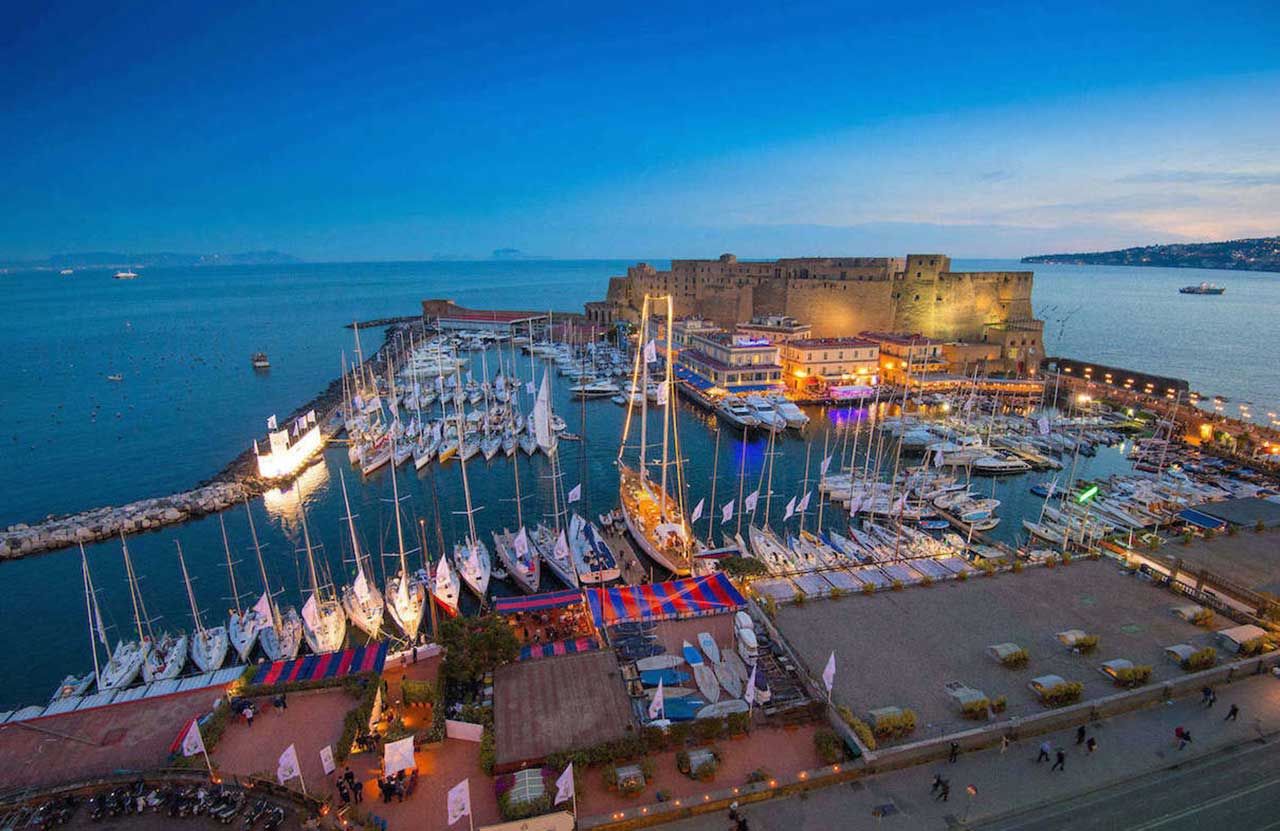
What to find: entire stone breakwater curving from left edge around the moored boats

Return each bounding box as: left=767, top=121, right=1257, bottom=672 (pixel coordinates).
left=0, top=319, right=416, bottom=560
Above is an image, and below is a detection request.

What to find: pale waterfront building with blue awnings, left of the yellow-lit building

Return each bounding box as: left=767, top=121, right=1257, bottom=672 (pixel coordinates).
left=676, top=332, right=782, bottom=393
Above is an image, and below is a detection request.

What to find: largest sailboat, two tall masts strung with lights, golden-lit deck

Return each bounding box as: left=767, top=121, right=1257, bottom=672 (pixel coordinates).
left=617, top=294, right=698, bottom=575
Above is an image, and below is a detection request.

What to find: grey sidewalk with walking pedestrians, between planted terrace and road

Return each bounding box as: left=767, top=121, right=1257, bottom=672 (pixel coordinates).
left=668, top=675, right=1280, bottom=831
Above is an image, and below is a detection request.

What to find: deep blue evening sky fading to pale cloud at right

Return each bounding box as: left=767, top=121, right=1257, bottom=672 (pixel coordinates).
left=0, top=1, right=1280, bottom=260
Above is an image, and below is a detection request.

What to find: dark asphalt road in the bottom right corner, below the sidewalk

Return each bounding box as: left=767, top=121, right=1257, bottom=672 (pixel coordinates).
left=972, top=743, right=1280, bottom=831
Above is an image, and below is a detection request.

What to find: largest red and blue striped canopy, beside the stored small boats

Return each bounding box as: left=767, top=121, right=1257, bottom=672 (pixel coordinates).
left=586, top=571, right=746, bottom=626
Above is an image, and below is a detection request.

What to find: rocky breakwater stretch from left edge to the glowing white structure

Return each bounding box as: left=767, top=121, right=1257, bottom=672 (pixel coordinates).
left=0, top=481, right=253, bottom=558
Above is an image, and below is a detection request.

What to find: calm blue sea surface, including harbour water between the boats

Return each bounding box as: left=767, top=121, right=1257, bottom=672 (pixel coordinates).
left=0, top=261, right=1280, bottom=709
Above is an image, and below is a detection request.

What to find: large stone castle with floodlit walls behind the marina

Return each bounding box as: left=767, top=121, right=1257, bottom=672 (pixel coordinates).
left=586, top=254, right=1044, bottom=351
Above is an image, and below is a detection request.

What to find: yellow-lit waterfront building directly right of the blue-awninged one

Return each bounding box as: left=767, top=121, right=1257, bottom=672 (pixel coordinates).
left=778, top=338, right=879, bottom=398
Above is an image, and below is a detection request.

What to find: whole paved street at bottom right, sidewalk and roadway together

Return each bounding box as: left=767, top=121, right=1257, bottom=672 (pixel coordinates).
left=668, top=676, right=1280, bottom=831
